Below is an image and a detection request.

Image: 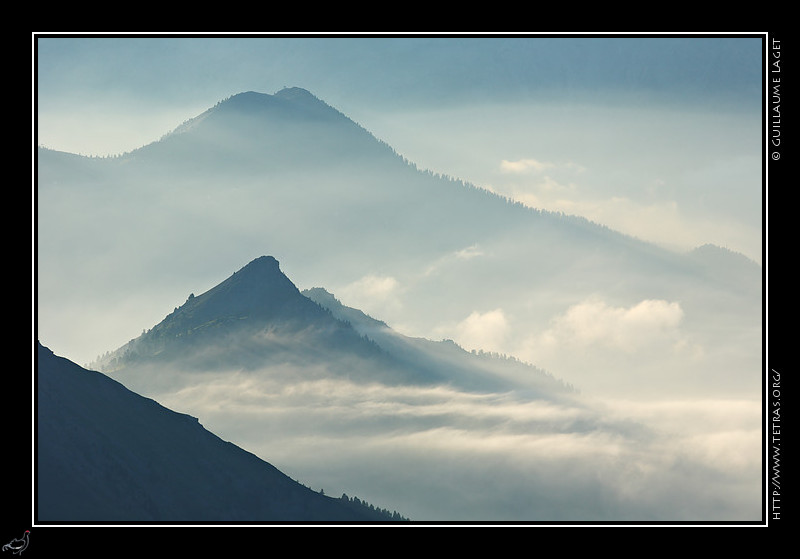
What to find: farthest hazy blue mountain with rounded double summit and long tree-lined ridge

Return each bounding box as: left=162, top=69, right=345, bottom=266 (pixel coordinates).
left=37, top=88, right=764, bottom=306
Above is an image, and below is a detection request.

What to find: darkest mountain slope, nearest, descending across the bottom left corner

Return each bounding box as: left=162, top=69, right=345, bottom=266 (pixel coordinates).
left=36, top=344, right=406, bottom=522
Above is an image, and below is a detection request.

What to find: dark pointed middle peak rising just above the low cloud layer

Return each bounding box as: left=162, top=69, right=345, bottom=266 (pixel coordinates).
left=93, top=256, right=412, bottom=382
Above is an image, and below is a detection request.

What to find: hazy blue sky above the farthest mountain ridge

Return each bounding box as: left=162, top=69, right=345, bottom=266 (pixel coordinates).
left=34, top=36, right=762, bottom=262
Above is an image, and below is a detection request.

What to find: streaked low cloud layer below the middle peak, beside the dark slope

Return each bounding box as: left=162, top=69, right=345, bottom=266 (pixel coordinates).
left=133, top=370, right=760, bottom=521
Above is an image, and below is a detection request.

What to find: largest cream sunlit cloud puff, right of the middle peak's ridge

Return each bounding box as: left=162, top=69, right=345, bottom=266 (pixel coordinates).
left=508, top=297, right=712, bottom=399
